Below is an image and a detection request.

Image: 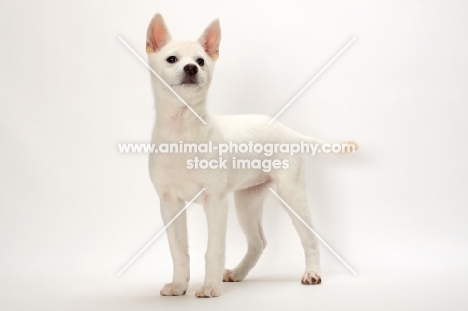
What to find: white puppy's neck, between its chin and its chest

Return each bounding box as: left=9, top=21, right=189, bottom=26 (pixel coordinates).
left=153, top=93, right=208, bottom=142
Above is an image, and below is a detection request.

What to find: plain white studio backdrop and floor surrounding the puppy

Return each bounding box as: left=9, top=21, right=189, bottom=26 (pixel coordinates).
left=0, top=0, right=468, bottom=310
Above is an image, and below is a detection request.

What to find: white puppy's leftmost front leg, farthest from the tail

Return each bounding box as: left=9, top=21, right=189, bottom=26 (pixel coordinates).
left=160, top=197, right=190, bottom=296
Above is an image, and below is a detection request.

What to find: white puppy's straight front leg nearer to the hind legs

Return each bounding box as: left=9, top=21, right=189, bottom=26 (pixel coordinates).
left=196, top=193, right=228, bottom=297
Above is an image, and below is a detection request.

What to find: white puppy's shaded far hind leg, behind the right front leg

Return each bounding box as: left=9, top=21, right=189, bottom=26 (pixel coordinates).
left=223, top=182, right=269, bottom=282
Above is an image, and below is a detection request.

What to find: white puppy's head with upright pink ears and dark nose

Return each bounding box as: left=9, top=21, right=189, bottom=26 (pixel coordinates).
left=146, top=14, right=221, bottom=98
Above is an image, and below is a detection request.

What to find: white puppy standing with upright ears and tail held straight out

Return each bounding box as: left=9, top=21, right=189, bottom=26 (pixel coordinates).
left=146, top=14, right=357, bottom=297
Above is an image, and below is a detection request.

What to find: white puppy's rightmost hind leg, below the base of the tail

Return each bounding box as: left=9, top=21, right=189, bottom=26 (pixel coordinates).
left=274, top=157, right=322, bottom=285
